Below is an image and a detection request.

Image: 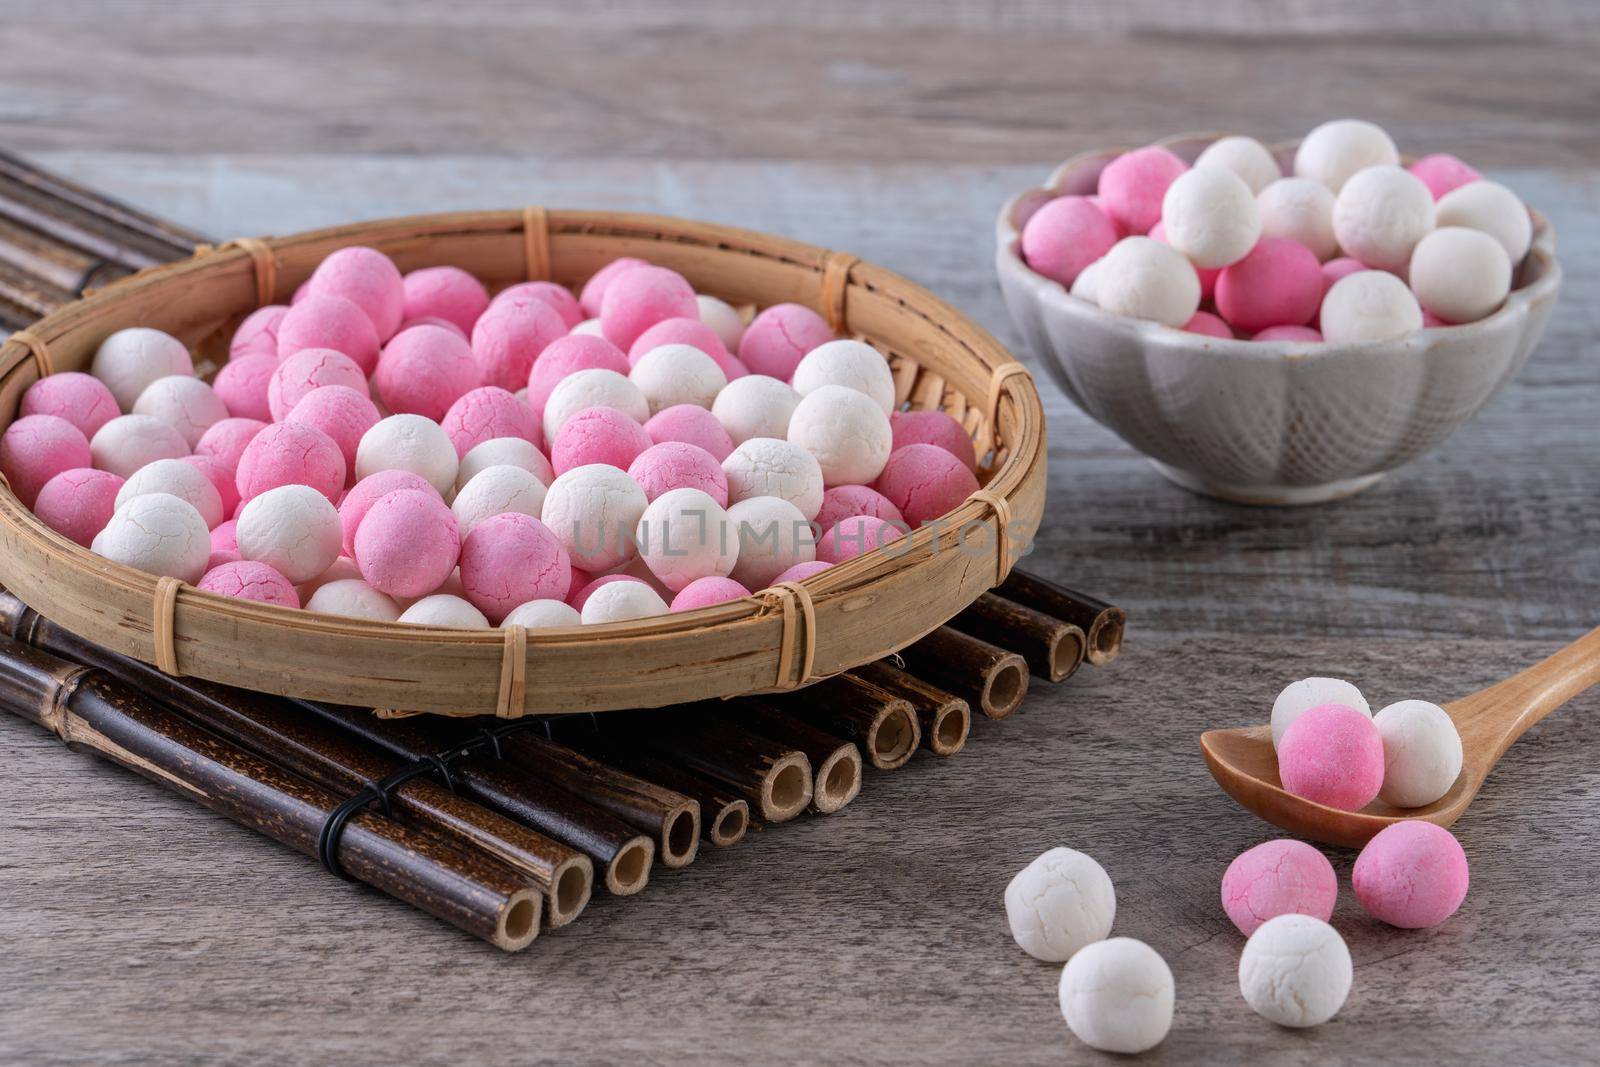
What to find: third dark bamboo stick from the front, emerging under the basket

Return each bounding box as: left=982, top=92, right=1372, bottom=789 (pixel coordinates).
left=291, top=701, right=656, bottom=896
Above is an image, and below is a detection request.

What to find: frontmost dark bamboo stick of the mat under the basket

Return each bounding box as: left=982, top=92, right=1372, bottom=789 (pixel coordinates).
left=0, top=637, right=542, bottom=952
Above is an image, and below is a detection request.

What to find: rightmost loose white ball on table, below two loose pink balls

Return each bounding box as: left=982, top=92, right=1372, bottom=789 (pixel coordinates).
left=1238, top=915, right=1354, bottom=1027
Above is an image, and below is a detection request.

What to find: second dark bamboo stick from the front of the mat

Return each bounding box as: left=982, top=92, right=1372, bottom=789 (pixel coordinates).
left=0, top=590, right=594, bottom=928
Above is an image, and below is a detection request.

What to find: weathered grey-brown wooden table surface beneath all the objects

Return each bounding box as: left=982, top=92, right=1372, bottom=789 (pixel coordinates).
left=0, top=0, right=1600, bottom=1064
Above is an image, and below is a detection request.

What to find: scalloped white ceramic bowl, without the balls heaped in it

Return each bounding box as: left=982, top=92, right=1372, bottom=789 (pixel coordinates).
left=995, top=134, right=1562, bottom=504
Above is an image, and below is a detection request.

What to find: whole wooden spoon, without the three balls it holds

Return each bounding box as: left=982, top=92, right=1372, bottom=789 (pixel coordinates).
left=1200, top=629, right=1600, bottom=848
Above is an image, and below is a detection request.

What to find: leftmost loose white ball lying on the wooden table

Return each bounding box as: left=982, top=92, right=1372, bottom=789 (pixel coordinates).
left=1005, top=848, right=1117, bottom=963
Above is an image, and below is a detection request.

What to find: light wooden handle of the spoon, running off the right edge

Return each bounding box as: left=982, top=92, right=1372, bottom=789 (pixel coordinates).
left=1448, top=627, right=1600, bottom=765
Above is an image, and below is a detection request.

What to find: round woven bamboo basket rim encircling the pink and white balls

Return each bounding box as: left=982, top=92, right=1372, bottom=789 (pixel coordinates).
left=0, top=208, right=1046, bottom=717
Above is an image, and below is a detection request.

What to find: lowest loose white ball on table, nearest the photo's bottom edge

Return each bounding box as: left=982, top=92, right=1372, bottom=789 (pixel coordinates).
left=1059, top=937, right=1176, bottom=1053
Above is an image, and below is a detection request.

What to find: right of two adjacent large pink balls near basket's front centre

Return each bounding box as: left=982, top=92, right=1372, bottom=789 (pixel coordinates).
left=461, top=512, right=573, bottom=625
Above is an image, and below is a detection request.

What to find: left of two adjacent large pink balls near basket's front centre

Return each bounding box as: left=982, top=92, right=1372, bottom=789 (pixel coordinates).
left=355, top=490, right=460, bottom=606
